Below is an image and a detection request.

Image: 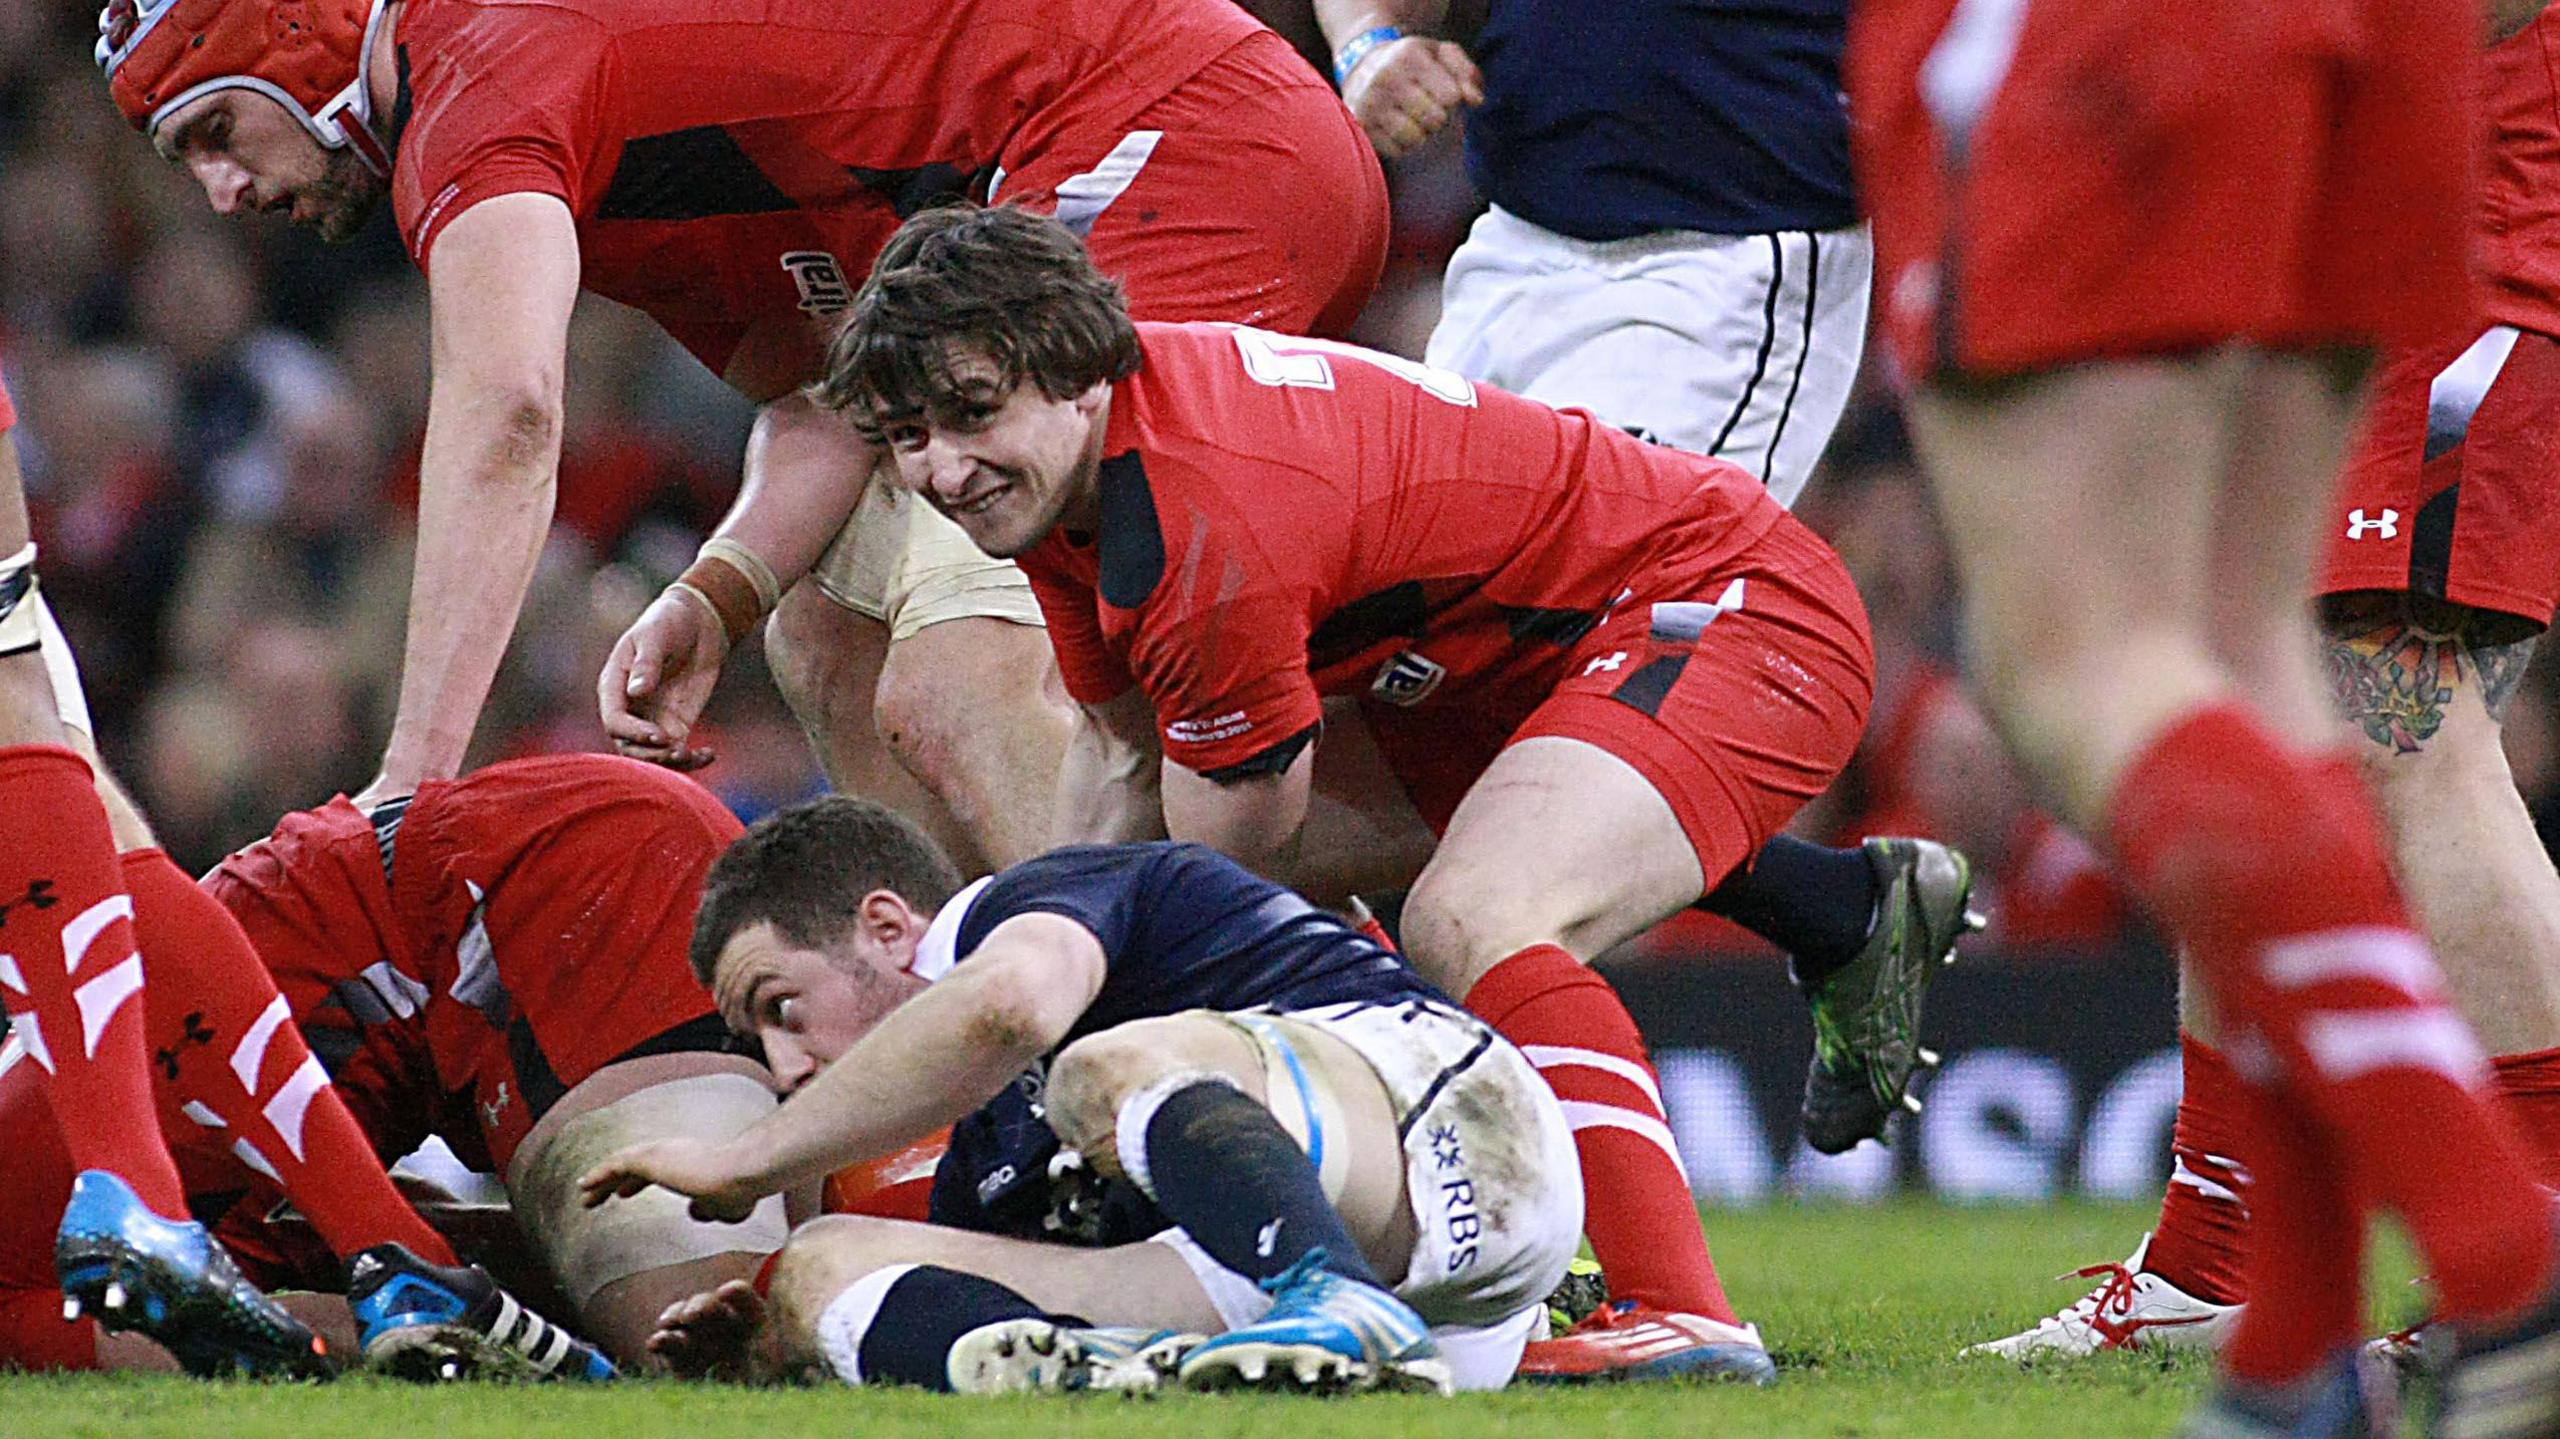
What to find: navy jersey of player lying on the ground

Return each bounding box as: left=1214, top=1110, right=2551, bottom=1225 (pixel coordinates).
left=916, top=842, right=1449, bottom=1244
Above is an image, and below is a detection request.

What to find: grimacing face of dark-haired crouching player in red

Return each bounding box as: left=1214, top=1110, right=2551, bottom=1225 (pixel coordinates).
left=878, top=356, right=1111, bottom=558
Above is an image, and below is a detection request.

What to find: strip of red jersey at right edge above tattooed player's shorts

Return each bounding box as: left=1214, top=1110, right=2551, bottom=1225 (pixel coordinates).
left=2481, top=10, right=2560, bottom=335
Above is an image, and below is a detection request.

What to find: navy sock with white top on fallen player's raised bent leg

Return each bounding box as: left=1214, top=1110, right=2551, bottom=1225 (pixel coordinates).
left=1119, top=1078, right=1388, bottom=1288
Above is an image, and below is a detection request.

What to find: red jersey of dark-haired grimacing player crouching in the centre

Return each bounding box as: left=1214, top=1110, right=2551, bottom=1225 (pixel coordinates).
left=1021, top=323, right=1782, bottom=771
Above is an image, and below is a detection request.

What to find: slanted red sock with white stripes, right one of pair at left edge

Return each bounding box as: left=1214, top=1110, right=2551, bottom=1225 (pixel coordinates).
left=125, top=850, right=456, bottom=1265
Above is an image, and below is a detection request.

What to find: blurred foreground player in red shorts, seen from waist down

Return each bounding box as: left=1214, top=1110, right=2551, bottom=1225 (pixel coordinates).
left=1848, top=0, right=2560, bottom=1436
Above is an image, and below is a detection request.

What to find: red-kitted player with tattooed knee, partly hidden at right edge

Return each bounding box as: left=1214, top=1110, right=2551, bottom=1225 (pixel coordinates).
left=1969, top=2, right=2560, bottom=1360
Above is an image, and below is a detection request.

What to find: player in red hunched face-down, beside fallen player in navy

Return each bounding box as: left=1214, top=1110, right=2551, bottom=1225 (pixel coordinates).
left=205, top=755, right=786, bottom=1365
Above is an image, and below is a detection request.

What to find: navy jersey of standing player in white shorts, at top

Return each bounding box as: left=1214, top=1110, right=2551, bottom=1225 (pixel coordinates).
left=1467, top=0, right=1859, bottom=241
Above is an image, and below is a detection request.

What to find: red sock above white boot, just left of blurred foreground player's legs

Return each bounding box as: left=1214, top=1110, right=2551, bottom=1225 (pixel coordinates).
left=2143, top=1034, right=2250, bottom=1303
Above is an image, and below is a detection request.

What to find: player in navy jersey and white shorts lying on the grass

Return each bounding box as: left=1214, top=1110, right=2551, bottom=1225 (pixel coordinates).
left=584, top=799, right=1582, bottom=1390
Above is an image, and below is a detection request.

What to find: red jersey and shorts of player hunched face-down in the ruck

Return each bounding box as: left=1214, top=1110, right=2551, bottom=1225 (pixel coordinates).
left=205, top=755, right=742, bottom=1106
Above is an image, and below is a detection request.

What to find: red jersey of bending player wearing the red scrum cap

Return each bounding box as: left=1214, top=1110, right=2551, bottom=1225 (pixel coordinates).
left=392, top=0, right=1262, bottom=371
